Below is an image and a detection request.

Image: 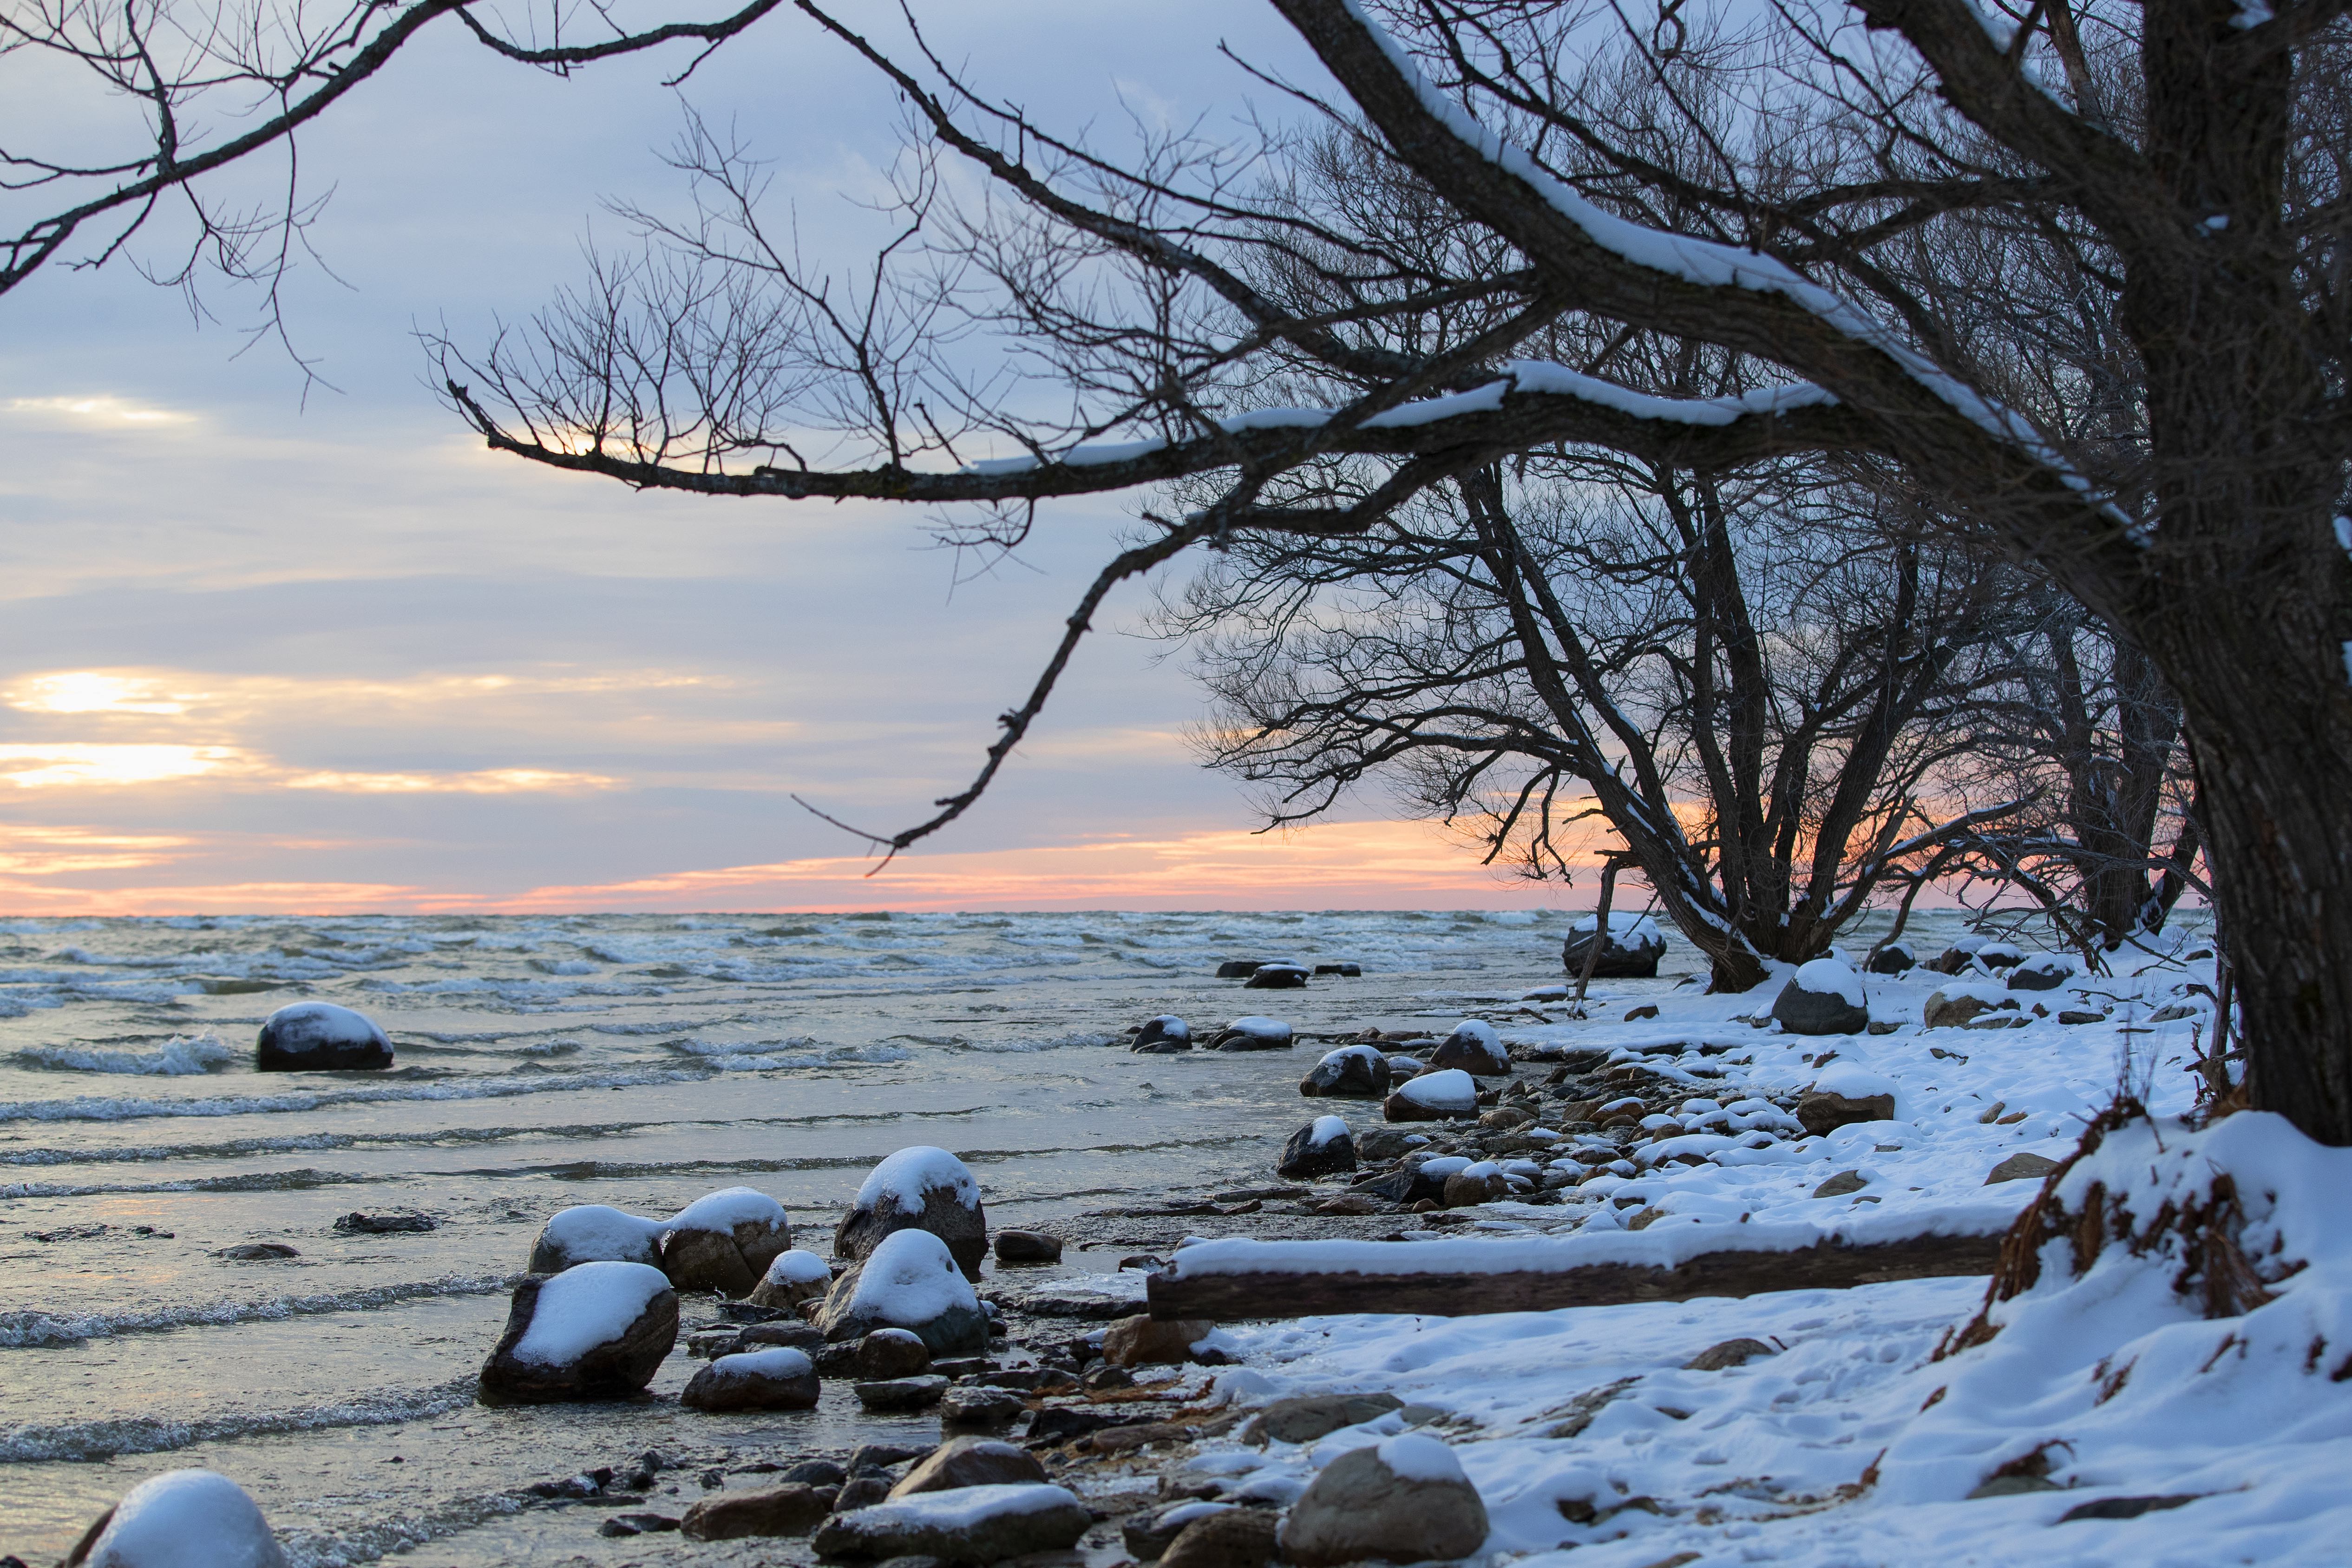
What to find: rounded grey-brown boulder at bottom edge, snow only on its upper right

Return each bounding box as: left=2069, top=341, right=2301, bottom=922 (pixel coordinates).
left=1282, top=1431, right=1487, bottom=1568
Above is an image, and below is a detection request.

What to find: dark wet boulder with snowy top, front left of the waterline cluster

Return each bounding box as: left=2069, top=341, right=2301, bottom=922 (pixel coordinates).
left=478, top=1262, right=677, bottom=1406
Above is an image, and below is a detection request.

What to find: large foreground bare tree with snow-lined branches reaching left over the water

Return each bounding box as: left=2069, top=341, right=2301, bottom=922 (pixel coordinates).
left=395, top=0, right=2352, bottom=1143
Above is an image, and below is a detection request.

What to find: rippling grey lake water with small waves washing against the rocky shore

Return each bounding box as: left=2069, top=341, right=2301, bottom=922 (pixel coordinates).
left=0, top=912, right=1985, bottom=1563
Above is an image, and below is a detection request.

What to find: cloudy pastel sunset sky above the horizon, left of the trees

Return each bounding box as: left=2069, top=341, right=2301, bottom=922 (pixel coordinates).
left=0, top=0, right=1592, bottom=915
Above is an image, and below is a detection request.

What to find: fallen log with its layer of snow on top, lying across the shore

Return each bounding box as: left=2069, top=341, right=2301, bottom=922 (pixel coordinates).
left=1146, top=1225, right=2004, bottom=1321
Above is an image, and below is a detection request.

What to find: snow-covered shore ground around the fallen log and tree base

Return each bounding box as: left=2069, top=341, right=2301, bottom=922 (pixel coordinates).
left=1138, top=945, right=2352, bottom=1568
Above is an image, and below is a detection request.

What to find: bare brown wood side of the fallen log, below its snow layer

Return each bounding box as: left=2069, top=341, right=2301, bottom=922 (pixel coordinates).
left=1146, top=1234, right=2002, bottom=1321
